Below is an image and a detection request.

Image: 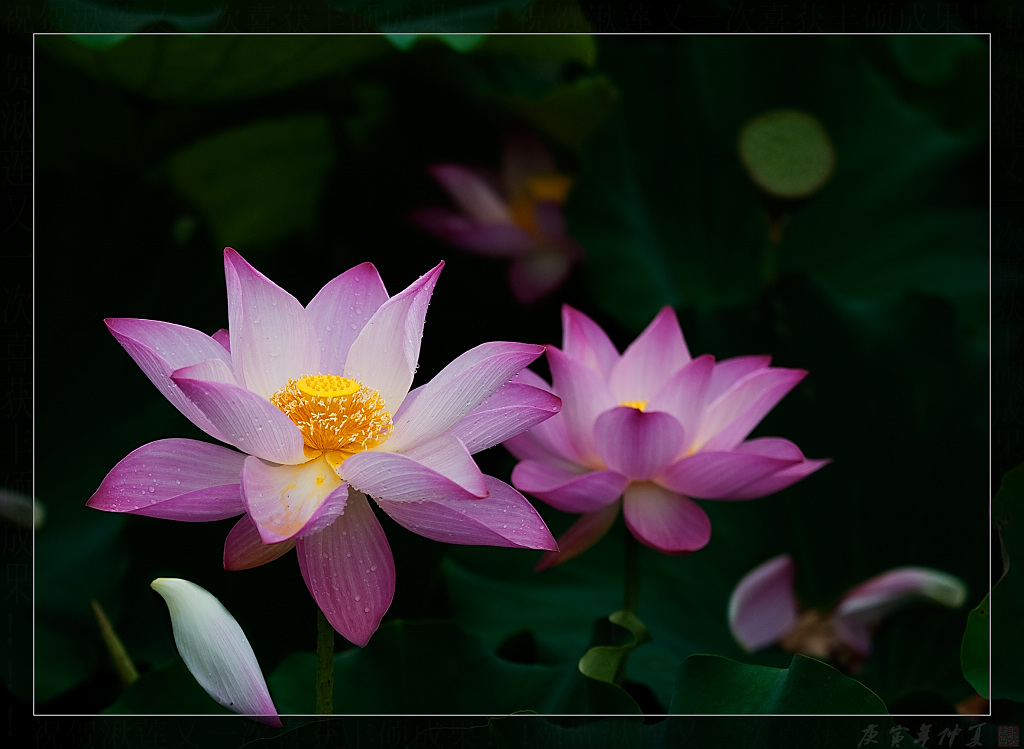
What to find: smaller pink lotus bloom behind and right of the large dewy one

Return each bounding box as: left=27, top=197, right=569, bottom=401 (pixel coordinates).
left=505, top=306, right=828, bottom=569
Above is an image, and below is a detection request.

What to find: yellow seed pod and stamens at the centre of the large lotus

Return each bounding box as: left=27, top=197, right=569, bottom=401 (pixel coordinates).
left=270, top=374, right=392, bottom=462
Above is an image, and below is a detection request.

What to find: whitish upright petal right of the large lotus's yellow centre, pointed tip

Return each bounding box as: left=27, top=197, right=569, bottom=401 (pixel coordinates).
left=343, top=262, right=444, bottom=414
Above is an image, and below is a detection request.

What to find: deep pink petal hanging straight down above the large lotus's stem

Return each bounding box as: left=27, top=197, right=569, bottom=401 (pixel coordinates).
left=296, top=492, right=395, bottom=648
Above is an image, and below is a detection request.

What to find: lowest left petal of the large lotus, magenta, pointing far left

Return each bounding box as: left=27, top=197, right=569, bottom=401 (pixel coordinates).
left=86, top=440, right=246, bottom=522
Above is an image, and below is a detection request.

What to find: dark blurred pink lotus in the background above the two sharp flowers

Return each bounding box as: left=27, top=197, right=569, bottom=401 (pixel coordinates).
left=412, top=133, right=583, bottom=302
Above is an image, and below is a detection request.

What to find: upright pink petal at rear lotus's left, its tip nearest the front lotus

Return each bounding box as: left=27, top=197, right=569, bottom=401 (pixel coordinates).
left=546, top=346, right=618, bottom=467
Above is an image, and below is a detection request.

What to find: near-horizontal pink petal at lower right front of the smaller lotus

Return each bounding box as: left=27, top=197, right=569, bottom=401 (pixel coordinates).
left=657, top=450, right=797, bottom=499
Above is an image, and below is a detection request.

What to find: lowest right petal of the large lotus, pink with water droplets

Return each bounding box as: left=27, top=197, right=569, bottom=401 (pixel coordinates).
left=378, top=476, right=558, bottom=550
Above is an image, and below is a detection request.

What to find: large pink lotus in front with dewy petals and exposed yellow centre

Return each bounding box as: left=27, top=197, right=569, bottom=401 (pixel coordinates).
left=88, top=248, right=559, bottom=646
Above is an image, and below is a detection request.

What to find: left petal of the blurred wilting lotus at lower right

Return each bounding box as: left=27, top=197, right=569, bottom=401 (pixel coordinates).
left=729, top=554, right=799, bottom=653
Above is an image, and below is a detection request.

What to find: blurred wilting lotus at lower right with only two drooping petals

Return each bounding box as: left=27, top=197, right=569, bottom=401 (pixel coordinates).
left=729, top=554, right=967, bottom=670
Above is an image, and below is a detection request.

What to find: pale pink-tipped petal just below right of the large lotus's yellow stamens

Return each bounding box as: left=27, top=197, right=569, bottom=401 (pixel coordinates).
left=339, top=440, right=486, bottom=502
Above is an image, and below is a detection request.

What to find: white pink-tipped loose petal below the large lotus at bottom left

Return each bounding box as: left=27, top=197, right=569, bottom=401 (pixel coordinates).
left=151, top=577, right=281, bottom=729
